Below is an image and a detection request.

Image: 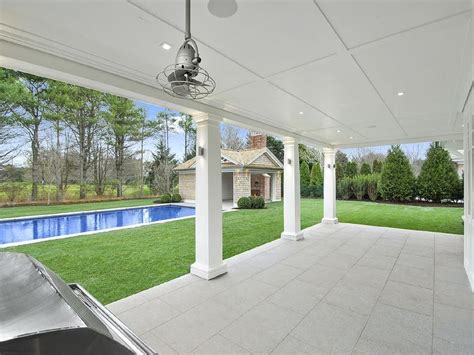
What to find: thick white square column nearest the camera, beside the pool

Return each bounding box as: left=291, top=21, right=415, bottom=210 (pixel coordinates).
left=191, top=114, right=227, bottom=280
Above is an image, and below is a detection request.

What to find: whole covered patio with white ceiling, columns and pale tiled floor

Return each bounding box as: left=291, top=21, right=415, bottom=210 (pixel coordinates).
left=0, top=0, right=474, bottom=354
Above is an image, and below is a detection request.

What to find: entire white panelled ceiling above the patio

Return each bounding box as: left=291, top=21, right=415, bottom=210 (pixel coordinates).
left=0, top=0, right=472, bottom=146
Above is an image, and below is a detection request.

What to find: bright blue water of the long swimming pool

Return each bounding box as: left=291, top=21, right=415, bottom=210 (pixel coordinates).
left=0, top=205, right=195, bottom=244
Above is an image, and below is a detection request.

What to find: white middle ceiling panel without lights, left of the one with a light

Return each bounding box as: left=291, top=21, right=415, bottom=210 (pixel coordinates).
left=271, top=55, right=392, bottom=124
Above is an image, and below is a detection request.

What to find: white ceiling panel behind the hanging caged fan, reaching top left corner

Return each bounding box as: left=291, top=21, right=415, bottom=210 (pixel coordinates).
left=2, top=1, right=256, bottom=92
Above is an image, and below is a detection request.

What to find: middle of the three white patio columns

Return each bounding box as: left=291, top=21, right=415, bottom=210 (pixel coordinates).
left=281, top=138, right=303, bottom=240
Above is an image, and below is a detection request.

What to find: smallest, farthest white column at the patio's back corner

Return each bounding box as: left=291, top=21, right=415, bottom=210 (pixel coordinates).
left=321, top=148, right=338, bottom=224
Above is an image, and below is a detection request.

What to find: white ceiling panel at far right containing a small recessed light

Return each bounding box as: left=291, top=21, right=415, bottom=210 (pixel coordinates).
left=355, top=15, right=469, bottom=126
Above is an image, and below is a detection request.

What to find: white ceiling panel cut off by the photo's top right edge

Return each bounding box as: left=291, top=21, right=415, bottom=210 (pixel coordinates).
left=318, top=0, right=471, bottom=48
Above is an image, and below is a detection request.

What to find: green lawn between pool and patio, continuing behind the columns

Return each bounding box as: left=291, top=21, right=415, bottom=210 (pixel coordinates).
left=2, top=199, right=463, bottom=303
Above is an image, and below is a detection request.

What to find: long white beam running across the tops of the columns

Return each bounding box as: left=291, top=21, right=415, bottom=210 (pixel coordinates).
left=0, top=39, right=330, bottom=146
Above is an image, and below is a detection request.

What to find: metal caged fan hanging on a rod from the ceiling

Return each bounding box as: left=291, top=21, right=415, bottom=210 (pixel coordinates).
left=156, top=0, right=216, bottom=100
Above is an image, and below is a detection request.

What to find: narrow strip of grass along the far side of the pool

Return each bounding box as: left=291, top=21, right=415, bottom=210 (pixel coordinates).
left=0, top=197, right=156, bottom=218
